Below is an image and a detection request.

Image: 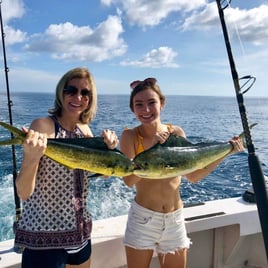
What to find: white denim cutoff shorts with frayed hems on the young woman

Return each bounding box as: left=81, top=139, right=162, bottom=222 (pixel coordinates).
left=124, top=201, right=191, bottom=254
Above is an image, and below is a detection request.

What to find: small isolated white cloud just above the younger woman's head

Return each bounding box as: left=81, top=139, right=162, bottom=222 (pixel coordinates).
left=121, top=47, right=179, bottom=68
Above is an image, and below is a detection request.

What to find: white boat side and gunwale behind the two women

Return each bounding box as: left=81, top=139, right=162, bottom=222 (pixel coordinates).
left=0, top=198, right=268, bottom=268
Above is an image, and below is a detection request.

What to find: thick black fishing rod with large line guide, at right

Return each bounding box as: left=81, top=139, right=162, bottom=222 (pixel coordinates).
left=216, top=0, right=268, bottom=260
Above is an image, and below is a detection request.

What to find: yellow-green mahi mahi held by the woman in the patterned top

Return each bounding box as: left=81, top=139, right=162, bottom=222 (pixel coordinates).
left=0, top=122, right=134, bottom=177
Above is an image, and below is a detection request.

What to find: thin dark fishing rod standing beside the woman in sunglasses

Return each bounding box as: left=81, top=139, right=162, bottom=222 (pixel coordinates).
left=0, top=1, right=21, bottom=234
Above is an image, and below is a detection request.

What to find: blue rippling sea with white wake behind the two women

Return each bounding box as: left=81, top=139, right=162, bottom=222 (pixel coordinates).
left=0, top=92, right=268, bottom=241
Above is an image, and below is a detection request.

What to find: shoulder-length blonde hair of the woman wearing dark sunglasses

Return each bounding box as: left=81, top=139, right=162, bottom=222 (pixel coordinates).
left=48, top=67, right=97, bottom=124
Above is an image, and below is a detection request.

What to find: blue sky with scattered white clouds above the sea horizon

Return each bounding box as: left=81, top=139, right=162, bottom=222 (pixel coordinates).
left=0, top=0, right=268, bottom=97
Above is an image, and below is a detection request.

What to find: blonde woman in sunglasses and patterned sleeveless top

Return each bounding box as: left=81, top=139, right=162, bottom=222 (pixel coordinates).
left=15, top=68, right=118, bottom=268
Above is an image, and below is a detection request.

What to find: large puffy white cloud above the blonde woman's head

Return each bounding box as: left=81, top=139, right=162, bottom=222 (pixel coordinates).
left=23, top=16, right=127, bottom=62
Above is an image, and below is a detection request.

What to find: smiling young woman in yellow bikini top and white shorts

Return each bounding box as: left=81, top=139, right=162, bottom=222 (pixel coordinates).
left=120, top=78, right=244, bottom=268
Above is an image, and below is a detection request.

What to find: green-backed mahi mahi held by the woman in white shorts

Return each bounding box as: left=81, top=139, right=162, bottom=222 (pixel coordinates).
left=133, top=124, right=256, bottom=179
